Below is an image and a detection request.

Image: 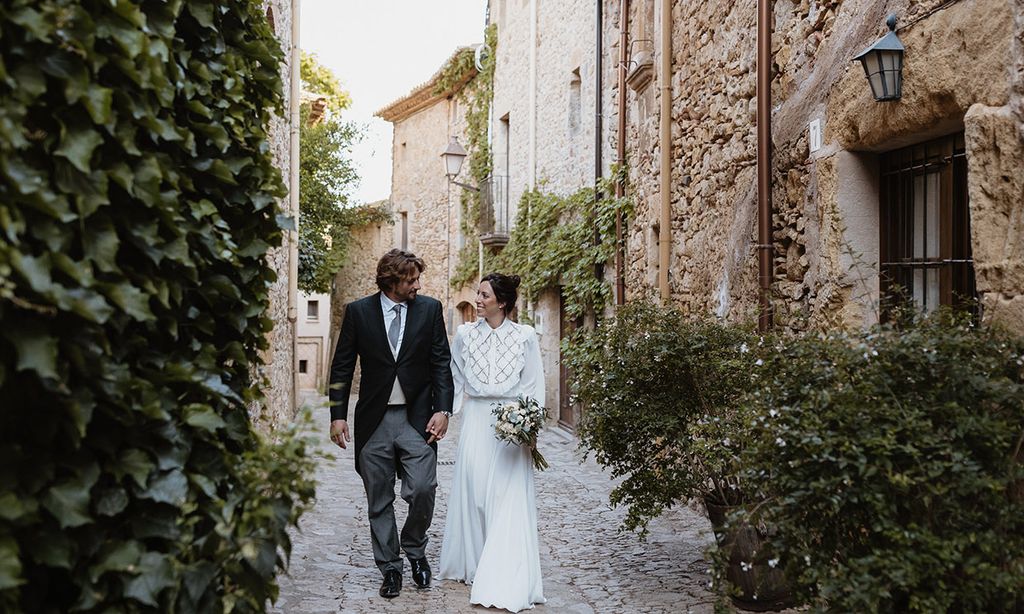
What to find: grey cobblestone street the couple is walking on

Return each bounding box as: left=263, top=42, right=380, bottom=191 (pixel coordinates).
left=271, top=401, right=714, bottom=614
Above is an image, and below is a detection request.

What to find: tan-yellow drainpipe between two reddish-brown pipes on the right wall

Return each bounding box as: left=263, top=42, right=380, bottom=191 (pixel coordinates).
left=657, top=0, right=675, bottom=305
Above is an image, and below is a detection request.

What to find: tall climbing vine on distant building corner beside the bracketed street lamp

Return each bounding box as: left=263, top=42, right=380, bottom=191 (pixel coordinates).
left=434, top=24, right=498, bottom=290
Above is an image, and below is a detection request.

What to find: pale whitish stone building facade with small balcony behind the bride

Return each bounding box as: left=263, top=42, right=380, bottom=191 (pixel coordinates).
left=488, top=0, right=608, bottom=428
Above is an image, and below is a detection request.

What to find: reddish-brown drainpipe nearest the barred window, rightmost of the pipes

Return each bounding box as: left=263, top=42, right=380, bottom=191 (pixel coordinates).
left=757, top=0, right=775, bottom=333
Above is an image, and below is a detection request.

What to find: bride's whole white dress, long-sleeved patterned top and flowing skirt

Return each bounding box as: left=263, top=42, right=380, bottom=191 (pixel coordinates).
left=440, top=318, right=545, bottom=612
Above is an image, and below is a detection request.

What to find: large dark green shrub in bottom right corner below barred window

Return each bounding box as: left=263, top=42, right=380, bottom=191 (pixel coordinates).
left=744, top=314, right=1024, bottom=612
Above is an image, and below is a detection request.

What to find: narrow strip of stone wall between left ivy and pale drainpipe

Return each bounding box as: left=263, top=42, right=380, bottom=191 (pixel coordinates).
left=260, top=0, right=296, bottom=430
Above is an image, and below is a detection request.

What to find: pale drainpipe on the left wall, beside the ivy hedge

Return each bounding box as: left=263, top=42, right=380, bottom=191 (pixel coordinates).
left=288, top=0, right=301, bottom=415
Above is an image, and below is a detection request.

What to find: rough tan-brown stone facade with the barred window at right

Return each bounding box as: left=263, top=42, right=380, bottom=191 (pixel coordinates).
left=604, top=0, right=1024, bottom=333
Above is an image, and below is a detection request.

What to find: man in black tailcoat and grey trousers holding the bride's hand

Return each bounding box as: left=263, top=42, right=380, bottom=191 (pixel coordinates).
left=331, top=250, right=455, bottom=599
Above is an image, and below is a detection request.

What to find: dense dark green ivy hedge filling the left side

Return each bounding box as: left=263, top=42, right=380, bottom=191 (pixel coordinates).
left=0, top=0, right=312, bottom=612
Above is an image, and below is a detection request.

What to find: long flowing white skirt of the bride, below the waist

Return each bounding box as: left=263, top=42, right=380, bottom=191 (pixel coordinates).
left=440, top=397, right=545, bottom=612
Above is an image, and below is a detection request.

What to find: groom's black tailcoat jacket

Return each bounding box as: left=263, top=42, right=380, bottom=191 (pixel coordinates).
left=331, top=293, right=455, bottom=472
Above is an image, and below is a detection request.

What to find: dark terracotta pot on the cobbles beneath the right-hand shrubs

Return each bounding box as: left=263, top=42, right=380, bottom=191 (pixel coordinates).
left=705, top=500, right=794, bottom=612
